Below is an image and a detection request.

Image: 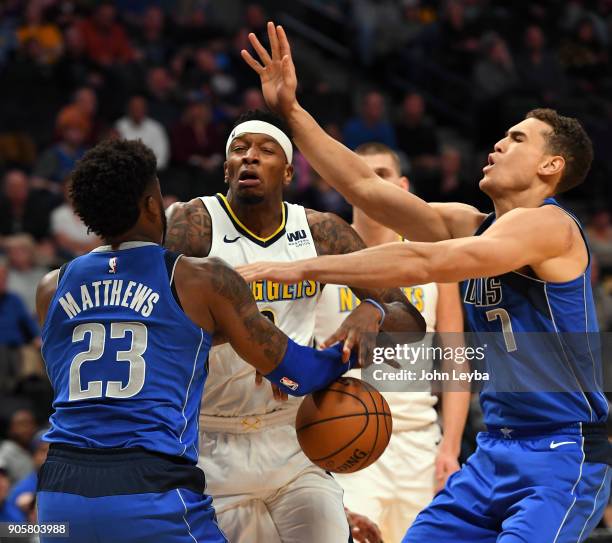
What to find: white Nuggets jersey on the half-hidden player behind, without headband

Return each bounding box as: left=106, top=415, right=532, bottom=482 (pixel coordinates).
left=315, top=283, right=438, bottom=431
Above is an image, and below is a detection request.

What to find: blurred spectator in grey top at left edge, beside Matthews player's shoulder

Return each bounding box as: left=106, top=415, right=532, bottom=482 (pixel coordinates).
left=4, top=234, right=49, bottom=316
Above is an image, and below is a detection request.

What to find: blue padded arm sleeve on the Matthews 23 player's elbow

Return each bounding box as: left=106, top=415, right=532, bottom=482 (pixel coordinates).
left=265, top=339, right=354, bottom=396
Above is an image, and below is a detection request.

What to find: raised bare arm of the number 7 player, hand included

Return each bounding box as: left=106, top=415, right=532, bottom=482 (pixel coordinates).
left=242, top=23, right=480, bottom=241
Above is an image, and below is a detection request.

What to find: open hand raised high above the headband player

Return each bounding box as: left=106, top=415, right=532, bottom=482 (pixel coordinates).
left=240, top=22, right=297, bottom=116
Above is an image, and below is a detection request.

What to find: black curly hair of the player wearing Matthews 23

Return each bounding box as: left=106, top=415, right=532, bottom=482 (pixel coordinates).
left=69, top=139, right=157, bottom=239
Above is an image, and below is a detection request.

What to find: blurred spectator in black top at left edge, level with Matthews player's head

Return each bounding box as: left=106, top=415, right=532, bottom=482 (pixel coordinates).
left=0, top=170, right=51, bottom=241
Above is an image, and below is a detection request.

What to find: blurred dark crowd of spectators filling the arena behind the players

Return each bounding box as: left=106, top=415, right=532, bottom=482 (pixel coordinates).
left=0, top=0, right=612, bottom=536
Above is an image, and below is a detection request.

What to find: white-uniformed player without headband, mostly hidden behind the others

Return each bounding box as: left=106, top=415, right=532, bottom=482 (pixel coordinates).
left=315, top=143, right=470, bottom=541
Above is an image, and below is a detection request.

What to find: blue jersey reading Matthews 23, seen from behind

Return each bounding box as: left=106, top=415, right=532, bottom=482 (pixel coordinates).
left=42, top=242, right=211, bottom=464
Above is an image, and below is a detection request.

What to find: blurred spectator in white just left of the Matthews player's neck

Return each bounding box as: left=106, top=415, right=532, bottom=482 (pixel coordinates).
left=51, top=180, right=100, bottom=260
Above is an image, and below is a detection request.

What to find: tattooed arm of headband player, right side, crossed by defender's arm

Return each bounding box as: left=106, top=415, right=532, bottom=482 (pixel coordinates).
left=307, top=210, right=422, bottom=330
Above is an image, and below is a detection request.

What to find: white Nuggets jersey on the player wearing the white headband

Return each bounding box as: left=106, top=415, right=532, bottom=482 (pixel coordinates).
left=202, top=194, right=320, bottom=418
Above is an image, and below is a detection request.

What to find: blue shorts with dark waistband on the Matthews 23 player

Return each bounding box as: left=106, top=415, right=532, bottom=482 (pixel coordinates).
left=37, top=445, right=227, bottom=543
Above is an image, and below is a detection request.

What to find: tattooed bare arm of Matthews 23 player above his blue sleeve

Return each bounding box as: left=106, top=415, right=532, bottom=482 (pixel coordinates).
left=209, top=258, right=287, bottom=371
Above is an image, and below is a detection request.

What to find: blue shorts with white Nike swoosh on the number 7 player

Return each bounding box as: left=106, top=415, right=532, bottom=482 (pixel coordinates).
left=403, top=425, right=612, bottom=543
